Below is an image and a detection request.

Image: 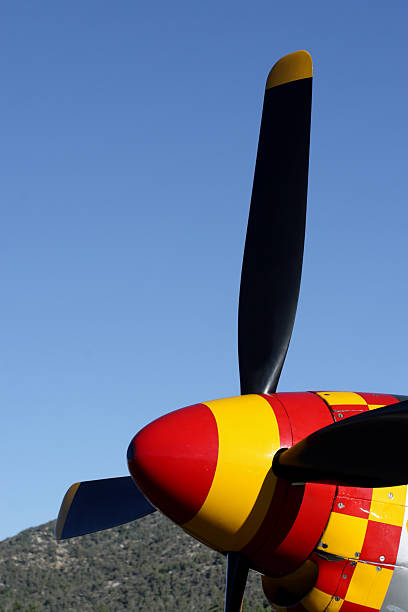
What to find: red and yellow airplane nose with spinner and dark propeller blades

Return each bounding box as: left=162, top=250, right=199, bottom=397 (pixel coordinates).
left=56, top=51, right=408, bottom=612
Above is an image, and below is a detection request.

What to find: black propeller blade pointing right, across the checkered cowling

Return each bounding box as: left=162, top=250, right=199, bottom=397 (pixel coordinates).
left=272, top=401, right=408, bottom=488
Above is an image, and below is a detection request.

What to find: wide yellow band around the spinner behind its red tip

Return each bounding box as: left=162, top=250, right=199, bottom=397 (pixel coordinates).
left=183, top=395, right=280, bottom=551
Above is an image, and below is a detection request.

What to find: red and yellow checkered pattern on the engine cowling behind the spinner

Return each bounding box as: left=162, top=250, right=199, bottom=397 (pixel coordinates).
left=295, top=391, right=407, bottom=612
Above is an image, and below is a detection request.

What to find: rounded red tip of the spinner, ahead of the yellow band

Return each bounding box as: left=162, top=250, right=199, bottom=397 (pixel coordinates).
left=128, top=404, right=218, bottom=525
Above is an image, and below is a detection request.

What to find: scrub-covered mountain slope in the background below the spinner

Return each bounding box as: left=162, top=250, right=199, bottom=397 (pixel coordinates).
left=0, top=513, right=271, bottom=612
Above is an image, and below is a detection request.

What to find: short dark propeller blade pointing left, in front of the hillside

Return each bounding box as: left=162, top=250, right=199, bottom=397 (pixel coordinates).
left=55, top=476, right=156, bottom=540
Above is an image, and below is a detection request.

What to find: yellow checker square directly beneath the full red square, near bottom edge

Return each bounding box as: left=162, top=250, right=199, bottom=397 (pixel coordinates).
left=345, top=563, right=393, bottom=610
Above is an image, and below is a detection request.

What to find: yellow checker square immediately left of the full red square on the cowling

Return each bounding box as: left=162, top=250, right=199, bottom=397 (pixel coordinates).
left=319, top=512, right=368, bottom=558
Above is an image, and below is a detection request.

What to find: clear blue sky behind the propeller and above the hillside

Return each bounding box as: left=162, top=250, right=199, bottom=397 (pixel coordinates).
left=0, top=0, right=408, bottom=538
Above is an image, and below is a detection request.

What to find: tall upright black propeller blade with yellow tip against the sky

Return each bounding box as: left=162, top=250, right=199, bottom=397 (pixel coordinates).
left=238, top=51, right=313, bottom=395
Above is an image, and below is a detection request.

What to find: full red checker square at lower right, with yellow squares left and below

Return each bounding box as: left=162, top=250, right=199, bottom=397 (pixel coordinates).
left=360, top=521, right=402, bottom=564
